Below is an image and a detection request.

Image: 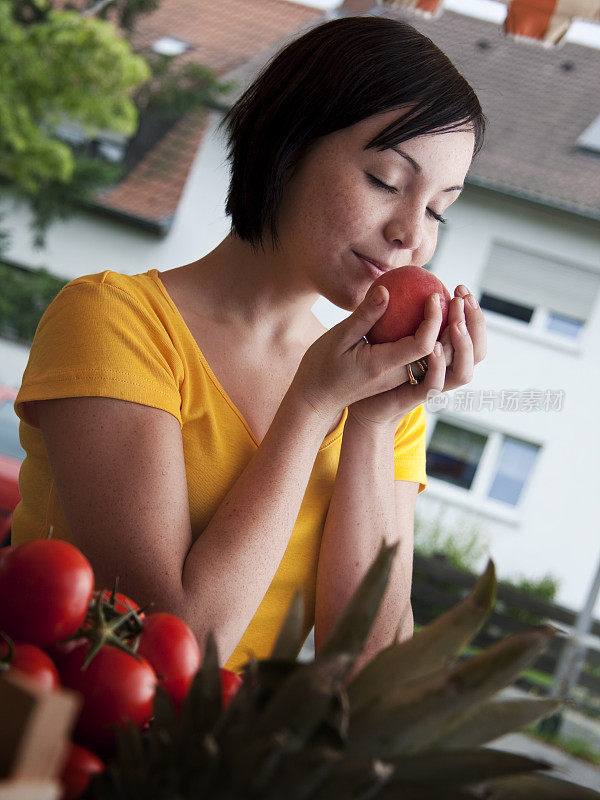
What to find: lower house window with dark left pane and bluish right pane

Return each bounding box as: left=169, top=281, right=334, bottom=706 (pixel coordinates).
left=427, top=419, right=540, bottom=506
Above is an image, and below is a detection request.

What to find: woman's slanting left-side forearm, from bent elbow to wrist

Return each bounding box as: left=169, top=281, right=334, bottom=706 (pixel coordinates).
left=182, top=388, right=329, bottom=663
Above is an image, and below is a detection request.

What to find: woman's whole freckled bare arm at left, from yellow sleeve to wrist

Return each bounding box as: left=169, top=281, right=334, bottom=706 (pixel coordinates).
left=36, top=384, right=328, bottom=663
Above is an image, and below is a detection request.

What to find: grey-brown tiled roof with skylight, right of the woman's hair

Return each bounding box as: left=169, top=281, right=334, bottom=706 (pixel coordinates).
left=370, top=9, right=600, bottom=220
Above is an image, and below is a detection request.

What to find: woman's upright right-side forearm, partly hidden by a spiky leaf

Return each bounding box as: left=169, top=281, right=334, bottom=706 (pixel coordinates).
left=315, top=417, right=413, bottom=674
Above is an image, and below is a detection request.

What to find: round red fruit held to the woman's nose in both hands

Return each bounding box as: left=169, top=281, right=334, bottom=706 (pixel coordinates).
left=367, top=266, right=451, bottom=344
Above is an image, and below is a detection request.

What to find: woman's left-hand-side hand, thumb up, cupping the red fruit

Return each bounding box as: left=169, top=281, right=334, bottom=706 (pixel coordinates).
left=292, top=286, right=442, bottom=422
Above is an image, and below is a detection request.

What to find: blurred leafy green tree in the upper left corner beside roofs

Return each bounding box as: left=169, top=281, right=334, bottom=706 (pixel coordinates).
left=0, top=0, right=233, bottom=253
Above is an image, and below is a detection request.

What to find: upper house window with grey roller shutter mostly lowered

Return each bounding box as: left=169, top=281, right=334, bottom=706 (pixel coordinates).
left=479, top=242, right=600, bottom=340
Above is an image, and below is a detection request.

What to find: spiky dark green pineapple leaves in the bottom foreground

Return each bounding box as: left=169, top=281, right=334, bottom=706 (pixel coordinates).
left=79, top=542, right=600, bottom=800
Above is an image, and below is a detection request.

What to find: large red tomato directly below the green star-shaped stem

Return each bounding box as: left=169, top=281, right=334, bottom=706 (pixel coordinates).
left=59, top=642, right=158, bottom=755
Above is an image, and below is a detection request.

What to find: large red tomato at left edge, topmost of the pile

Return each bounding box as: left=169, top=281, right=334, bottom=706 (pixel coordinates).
left=0, top=539, right=94, bottom=647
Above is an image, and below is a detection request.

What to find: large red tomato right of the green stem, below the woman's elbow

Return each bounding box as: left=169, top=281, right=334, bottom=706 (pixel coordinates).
left=137, top=612, right=201, bottom=708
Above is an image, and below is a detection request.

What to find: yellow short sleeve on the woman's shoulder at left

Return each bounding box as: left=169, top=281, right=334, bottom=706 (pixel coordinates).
left=14, top=276, right=182, bottom=428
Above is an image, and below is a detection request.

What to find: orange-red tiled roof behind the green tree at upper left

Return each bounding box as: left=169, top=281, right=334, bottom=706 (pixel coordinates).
left=67, top=0, right=323, bottom=233
